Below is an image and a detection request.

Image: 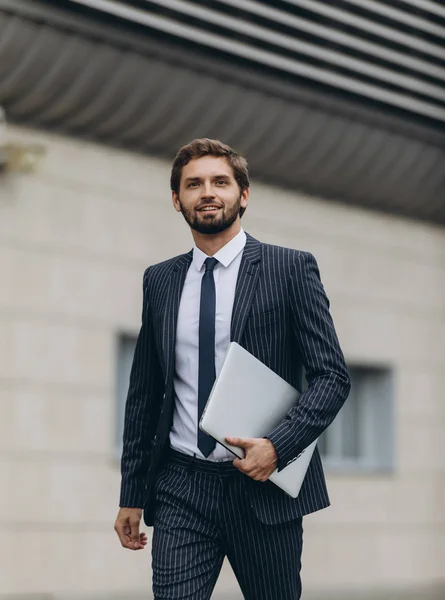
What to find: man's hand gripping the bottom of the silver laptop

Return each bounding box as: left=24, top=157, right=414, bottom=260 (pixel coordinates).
left=226, top=437, right=278, bottom=481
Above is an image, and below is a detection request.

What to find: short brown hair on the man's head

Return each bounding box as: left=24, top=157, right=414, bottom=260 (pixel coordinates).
left=170, top=138, right=250, bottom=217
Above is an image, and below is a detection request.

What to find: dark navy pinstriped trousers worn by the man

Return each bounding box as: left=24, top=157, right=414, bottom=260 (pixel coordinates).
left=152, top=452, right=303, bottom=600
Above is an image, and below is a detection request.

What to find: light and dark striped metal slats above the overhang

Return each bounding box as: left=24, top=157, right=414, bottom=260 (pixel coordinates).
left=70, top=0, right=445, bottom=124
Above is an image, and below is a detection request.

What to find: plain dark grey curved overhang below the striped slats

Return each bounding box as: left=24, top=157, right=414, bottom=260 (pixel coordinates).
left=0, top=0, right=445, bottom=224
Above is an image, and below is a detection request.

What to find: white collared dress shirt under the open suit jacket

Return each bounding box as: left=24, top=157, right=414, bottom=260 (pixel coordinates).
left=170, top=229, right=246, bottom=461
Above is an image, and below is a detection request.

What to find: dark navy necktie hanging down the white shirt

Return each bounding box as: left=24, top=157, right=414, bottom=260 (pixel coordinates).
left=198, top=258, right=218, bottom=457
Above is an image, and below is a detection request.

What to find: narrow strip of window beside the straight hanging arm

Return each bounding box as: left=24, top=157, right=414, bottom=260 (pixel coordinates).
left=114, top=334, right=137, bottom=460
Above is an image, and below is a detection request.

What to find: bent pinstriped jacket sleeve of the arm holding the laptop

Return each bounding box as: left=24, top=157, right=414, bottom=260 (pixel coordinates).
left=267, top=252, right=350, bottom=471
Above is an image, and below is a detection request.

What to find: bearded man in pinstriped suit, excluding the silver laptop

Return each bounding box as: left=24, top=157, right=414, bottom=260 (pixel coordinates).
left=115, top=139, right=350, bottom=600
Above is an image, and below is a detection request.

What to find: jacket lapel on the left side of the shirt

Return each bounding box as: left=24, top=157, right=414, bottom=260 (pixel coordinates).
left=162, top=251, right=193, bottom=383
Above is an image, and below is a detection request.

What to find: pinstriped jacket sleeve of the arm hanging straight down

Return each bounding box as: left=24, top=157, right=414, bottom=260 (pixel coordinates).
left=119, top=269, right=160, bottom=508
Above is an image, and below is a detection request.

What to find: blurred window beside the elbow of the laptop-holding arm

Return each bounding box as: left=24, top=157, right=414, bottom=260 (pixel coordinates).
left=318, top=366, right=394, bottom=471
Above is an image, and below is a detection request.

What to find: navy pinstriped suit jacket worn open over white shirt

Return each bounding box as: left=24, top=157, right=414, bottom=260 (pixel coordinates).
left=120, top=235, right=350, bottom=525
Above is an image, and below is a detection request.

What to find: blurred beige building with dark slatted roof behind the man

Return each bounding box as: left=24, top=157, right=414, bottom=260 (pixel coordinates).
left=0, top=0, right=445, bottom=600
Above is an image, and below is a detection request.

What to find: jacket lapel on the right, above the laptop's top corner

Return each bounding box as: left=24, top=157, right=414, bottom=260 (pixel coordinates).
left=230, top=234, right=262, bottom=343
